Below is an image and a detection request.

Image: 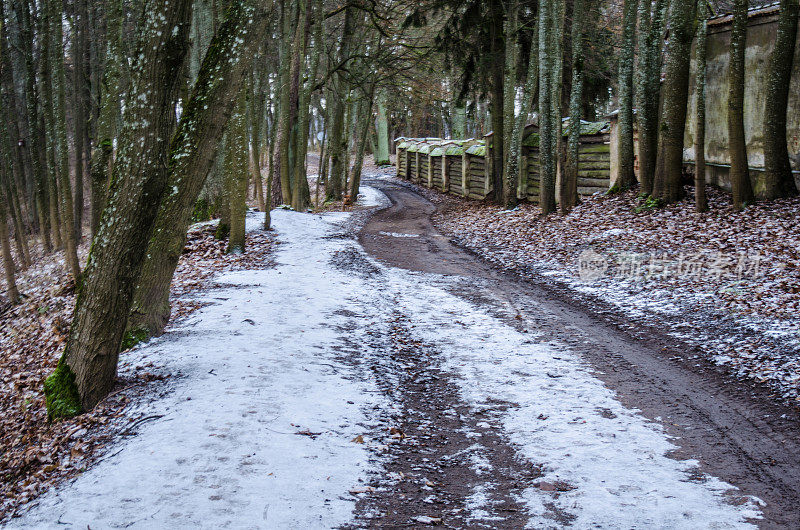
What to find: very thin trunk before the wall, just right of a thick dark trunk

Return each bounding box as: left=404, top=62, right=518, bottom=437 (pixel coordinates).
left=694, top=5, right=708, bottom=212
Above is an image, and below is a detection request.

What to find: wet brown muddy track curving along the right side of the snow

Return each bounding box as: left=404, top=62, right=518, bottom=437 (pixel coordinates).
left=359, top=176, right=800, bottom=528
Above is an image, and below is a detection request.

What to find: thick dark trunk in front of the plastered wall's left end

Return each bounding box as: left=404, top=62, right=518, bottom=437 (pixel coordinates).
left=653, top=0, right=695, bottom=203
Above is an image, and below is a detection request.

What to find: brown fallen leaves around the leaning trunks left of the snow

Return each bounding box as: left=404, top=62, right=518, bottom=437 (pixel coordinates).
left=0, top=217, right=275, bottom=521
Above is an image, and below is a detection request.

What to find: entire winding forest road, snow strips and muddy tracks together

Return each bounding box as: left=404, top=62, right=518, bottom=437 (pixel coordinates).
left=7, top=164, right=800, bottom=528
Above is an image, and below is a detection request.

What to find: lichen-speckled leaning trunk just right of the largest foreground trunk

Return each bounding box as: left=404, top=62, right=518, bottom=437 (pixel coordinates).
left=128, top=0, right=271, bottom=336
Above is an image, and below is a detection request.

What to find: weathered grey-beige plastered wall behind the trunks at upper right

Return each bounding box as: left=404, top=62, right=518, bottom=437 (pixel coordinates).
left=684, top=14, right=800, bottom=192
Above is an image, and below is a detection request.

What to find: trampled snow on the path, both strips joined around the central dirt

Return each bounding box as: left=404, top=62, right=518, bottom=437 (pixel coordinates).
left=10, top=189, right=758, bottom=530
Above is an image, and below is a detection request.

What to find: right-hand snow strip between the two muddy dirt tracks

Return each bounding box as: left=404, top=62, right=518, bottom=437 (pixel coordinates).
left=392, top=274, right=758, bottom=528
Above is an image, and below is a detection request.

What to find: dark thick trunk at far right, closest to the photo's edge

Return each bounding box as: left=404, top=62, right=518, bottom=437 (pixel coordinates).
left=764, top=0, right=800, bottom=199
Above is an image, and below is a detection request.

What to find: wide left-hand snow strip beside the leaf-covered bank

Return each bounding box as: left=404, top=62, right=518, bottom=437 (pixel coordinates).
left=12, top=210, right=390, bottom=529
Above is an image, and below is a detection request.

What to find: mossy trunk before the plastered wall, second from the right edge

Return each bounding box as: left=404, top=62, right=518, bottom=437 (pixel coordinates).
left=728, top=0, right=755, bottom=209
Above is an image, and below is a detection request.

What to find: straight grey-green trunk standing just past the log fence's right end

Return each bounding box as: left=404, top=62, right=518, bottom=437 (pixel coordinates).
left=617, top=0, right=647, bottom=190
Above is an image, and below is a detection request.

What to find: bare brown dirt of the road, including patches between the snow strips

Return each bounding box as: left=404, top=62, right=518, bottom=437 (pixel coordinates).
left=359, top=179, right=800, bottom=528
